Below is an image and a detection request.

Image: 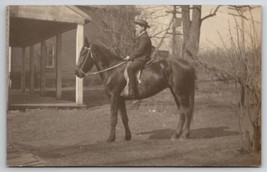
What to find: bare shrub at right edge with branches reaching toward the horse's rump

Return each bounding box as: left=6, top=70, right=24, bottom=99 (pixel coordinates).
left=195, top=6, right=261, bottom=153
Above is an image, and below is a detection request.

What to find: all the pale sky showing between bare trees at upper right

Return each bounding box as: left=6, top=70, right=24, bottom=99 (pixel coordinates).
left=138, top=5, right=261, bottom=51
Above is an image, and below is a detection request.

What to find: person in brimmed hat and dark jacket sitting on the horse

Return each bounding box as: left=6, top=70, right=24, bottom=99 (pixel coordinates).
left=125, top=20, right=152, bottom=99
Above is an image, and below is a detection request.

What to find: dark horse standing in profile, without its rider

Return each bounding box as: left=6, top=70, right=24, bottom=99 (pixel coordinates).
left=76, top=39, right=195, bottom=142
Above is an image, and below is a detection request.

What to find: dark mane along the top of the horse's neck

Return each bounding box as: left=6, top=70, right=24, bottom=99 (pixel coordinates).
left=91, top=41, right=123, bottom=60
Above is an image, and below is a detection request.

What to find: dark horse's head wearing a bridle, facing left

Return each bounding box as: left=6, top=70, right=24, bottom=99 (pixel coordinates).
left=75, top=38, right=95, bottom=78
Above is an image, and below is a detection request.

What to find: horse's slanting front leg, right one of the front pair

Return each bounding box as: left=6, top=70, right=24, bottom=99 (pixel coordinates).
left=119, top=99, right=132, bottom=141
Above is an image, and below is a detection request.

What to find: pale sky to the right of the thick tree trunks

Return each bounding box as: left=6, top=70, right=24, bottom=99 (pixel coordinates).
left=200, top=6, right=261, bottom=49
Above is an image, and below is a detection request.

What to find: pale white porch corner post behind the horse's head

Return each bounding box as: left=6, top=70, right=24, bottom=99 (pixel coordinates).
left=76, top=24, right=84, bottom=104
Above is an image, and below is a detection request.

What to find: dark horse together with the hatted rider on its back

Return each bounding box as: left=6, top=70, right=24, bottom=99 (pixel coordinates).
left=75, top=20, right=195, bottom=142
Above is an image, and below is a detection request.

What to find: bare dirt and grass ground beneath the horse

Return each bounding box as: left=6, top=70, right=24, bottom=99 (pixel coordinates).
left=7, top=83, right=261, bottom=166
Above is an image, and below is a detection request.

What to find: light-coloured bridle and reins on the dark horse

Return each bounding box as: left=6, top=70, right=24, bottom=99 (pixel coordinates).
left=79, top=46, right=127, bottom=76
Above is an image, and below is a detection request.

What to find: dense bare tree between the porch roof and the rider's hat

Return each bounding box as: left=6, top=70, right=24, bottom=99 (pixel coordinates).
left=79, top=5, right=140, bottom=57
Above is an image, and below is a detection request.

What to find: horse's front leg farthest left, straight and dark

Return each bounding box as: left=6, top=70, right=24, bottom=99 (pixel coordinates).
left=107, top=96, right=119, bottom=142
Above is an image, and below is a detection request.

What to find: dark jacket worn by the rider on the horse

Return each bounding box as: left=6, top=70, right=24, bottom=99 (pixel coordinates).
left=130, top=32, right=152, bottom=63
